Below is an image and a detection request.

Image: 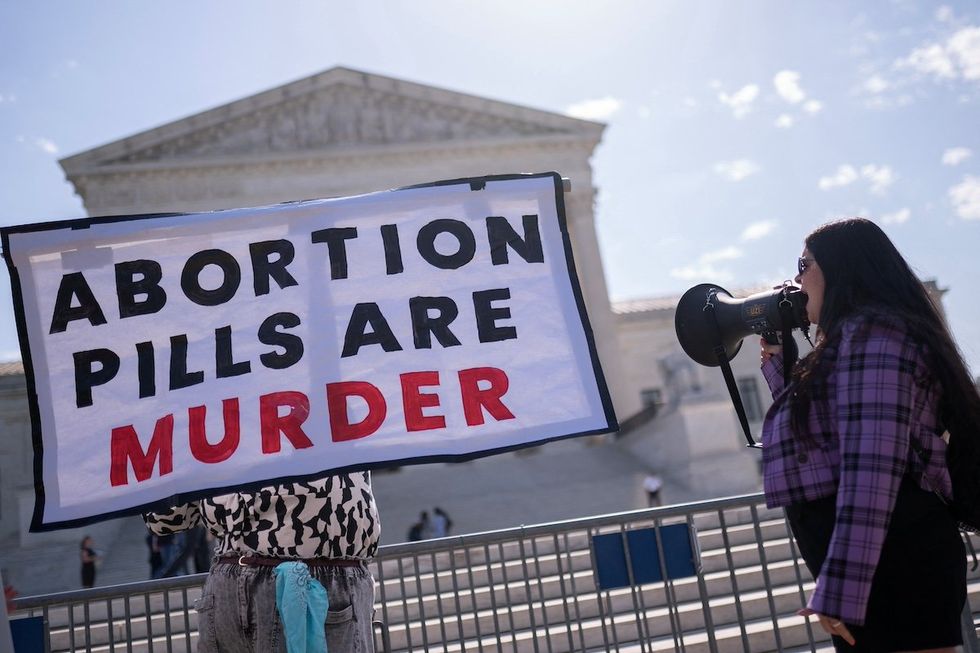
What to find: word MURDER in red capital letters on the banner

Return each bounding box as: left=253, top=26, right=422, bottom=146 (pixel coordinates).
left=109, top=367, right=514, bottom=487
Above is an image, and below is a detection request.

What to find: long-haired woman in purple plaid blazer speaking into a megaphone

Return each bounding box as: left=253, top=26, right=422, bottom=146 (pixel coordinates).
left=762, top=218, right=980, bottom=651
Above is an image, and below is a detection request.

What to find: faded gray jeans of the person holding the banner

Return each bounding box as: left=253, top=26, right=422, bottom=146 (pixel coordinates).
left=195, top=562, right=374, bottom=653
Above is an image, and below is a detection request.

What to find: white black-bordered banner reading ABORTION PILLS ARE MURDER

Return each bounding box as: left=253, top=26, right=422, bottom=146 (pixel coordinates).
left=0, top=173, right=616, bottom=530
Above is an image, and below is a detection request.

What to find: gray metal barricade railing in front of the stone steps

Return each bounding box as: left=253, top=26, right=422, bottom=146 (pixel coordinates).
left=13, top=494, right=980, bottom=653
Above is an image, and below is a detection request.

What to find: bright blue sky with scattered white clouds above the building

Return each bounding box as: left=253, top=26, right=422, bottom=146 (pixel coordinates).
left=0, top=0, right=980, bottom=374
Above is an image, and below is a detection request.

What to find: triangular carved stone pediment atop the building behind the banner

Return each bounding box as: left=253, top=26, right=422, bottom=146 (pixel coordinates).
left=61, top=67, right=604, bottom=176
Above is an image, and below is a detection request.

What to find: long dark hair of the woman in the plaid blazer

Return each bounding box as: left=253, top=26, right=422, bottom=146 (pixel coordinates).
left=791, top=218, right=980, bottom=471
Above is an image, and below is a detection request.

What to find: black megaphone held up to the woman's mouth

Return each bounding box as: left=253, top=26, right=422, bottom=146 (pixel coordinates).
left=674, top=283, right=810, bottom=367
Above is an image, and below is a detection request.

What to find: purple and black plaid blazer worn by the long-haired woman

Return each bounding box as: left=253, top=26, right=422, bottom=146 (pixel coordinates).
left=762, top=311, right=952, bottom=625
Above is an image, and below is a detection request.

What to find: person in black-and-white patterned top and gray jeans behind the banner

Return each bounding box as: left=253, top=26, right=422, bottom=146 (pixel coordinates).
left=144, top=472, right=381, bottom=653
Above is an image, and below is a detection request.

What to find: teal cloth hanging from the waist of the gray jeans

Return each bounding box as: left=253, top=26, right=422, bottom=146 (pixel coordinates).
left=273, top=562, right=330, bottom=653
